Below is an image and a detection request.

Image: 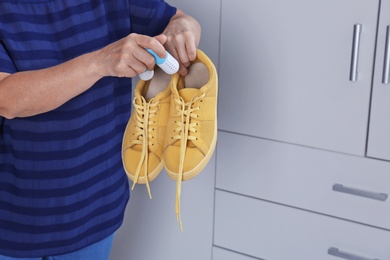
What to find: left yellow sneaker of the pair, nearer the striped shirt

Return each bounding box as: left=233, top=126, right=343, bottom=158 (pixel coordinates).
left=122, top=69, right=177, bottom=198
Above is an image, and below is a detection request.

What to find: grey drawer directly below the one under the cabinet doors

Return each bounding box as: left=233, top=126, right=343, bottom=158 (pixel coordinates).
left=214, top=191, right=390, bottom=260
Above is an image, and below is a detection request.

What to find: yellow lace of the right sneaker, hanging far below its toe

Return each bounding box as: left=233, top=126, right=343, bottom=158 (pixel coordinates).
left=172, top=93, right=205, bottom=231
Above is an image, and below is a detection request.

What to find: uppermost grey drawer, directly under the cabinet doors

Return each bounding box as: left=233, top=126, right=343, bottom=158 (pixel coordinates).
left=216, top=131, right=390, bottom=229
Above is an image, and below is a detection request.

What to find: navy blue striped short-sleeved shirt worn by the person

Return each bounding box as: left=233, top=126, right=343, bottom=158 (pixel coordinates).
left=0, top=0, right=176, bottom=257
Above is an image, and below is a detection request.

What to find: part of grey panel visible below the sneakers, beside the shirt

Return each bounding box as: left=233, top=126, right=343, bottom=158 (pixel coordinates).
left=110, top=157, right=215, bottom=260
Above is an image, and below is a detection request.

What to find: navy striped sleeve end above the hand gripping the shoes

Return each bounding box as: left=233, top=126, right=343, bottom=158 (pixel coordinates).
left=129, top=0, right=176, bottom=36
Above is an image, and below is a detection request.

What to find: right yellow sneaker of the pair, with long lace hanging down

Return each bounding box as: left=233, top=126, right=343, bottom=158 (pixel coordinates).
left=164, top=50, right=218, bottom=229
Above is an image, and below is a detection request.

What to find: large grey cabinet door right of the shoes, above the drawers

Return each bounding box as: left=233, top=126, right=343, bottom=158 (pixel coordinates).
left=219, top=0, right=378, bottom=155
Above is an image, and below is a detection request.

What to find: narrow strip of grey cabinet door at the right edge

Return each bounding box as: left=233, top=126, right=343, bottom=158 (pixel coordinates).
left=367, top=0, right=390, bottom=160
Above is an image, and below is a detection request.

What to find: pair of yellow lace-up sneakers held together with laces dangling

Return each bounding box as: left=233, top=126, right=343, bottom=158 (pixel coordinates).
left=122, top=49, right=218, bottom=234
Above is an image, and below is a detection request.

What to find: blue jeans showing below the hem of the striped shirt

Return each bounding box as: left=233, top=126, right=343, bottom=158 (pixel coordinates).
left=0, top=234, right=114, bottom=260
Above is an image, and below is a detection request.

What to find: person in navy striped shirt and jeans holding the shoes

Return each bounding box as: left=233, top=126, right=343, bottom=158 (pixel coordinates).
left=0, top=0, right=200, bottom=259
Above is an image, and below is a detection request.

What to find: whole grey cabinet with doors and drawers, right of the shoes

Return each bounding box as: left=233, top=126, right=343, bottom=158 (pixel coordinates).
left=213, top=0, right=390, bottom=260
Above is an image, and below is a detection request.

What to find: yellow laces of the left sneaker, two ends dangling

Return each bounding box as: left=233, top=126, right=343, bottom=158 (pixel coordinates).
left=130, top=96, right=160, bottom=198
